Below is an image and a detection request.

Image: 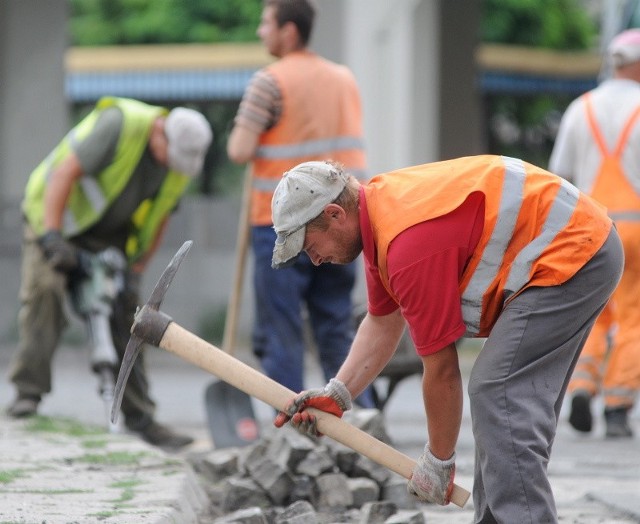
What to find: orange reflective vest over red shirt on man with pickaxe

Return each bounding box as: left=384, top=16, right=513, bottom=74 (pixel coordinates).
left=364, top=155, right=611, bottom=337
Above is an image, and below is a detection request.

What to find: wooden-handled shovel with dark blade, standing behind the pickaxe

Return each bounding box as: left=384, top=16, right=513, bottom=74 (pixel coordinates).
left=204, top=166, right=259, bottom=449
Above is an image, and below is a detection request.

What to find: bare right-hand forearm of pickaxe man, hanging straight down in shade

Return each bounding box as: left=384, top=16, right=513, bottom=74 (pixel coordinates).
left=422, top=344, right=463, bottom=460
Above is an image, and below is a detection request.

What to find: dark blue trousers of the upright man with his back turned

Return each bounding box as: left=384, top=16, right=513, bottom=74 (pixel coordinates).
left=252, top=226, right=374, bottom=407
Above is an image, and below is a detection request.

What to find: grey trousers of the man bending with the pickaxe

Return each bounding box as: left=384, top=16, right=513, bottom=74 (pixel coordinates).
left=469, top=229, right=624, bottom=524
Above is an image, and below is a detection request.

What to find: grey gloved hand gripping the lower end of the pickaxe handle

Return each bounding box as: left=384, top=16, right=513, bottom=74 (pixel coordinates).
left=407, top=443, right=456, bottom=506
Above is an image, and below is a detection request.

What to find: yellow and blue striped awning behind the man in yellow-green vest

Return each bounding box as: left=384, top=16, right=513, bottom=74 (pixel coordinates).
left=65, top=42, right=273, bottom=103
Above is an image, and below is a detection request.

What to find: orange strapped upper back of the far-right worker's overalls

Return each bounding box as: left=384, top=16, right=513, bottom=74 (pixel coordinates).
left=583, top=93, right=640, bottom=222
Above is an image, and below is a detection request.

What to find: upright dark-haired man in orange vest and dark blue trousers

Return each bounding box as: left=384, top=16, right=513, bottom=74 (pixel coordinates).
left=227, top=0, right=373, bottom=407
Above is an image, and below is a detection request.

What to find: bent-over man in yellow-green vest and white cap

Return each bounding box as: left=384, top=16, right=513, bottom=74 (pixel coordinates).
left=8, top=98, right=212, bottom=448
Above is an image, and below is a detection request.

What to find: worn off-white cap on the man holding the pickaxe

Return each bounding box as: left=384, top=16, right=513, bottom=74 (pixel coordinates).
left=271, top=161, right=349, bottom=269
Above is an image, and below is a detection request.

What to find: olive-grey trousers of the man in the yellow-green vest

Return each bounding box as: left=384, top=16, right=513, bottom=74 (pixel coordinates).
left=9, top=226, right=155, bottom=430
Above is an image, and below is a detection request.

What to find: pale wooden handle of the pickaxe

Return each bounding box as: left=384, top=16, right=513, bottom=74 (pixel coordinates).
left=159, top=322, right=469, bottom=508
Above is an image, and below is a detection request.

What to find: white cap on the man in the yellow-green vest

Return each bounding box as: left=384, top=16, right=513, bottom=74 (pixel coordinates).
left=164, top=107, right=213, bottom=176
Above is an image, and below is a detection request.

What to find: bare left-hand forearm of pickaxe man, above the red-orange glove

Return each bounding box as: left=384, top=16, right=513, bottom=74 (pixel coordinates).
left=336, top=309, right=405, bottom=398
